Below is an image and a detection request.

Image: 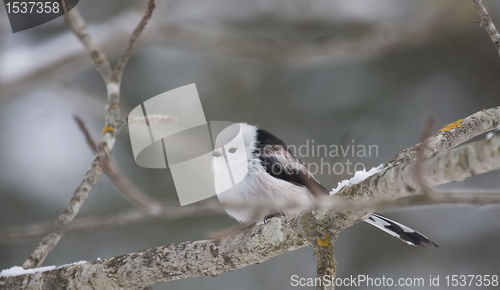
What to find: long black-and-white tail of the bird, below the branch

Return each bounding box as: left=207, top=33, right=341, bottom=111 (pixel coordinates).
left=365, top=213, right=438, bottom=247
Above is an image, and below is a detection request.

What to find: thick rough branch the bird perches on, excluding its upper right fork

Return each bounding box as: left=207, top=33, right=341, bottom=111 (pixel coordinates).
left=0, top=130, right=500, bottom=289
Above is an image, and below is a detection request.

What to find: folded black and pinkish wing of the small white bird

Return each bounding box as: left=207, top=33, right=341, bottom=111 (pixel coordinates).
left=254, top=129, right=329, bottom=196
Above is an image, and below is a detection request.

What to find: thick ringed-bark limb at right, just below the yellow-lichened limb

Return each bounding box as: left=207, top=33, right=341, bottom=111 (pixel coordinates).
left=336, top=135, right=500, bottom=203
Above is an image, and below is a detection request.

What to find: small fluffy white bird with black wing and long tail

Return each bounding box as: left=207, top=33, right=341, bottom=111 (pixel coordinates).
left=212, top=123, right=437, bottom=247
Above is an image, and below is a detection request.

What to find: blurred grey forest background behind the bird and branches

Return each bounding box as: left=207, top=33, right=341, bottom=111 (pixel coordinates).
left=0, top=0, right=500, bottom=290
